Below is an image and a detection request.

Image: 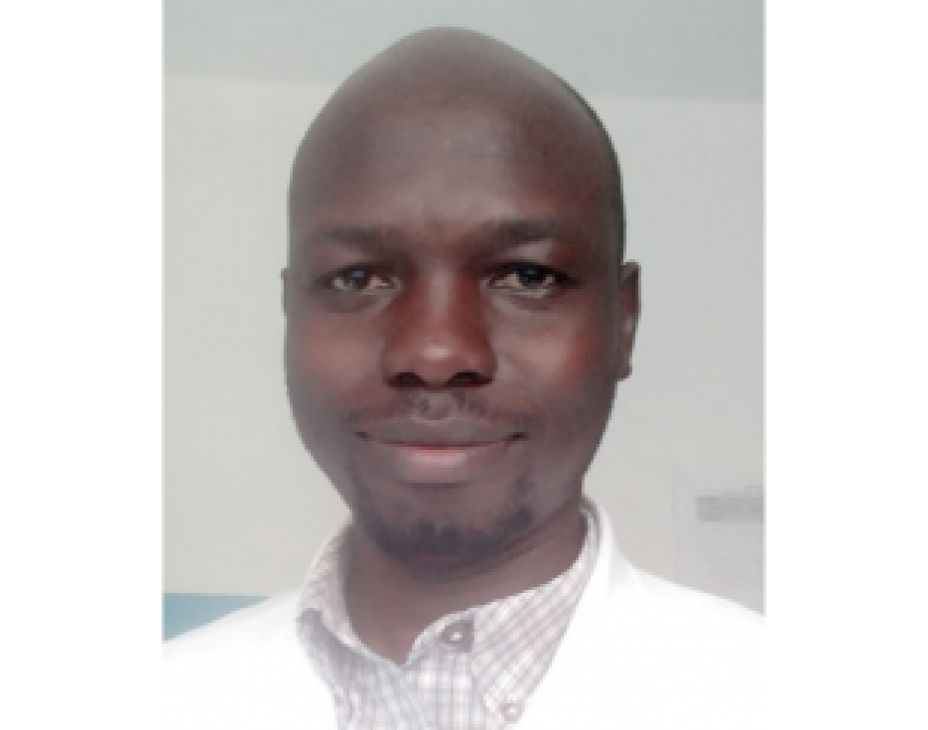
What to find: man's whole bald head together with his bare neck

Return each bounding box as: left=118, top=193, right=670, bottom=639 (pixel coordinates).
left=285, top=31, right=640, bottom=664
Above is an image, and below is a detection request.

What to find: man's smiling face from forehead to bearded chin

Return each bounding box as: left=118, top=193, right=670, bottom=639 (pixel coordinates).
left=286, top=96, right=638, bottom=570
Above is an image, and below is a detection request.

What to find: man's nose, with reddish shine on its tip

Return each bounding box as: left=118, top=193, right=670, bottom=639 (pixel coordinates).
left=383, top=278, right=497, bottom=390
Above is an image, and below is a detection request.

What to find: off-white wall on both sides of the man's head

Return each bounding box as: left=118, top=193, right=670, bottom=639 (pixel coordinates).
left=161, top=76, right=767, bottom=594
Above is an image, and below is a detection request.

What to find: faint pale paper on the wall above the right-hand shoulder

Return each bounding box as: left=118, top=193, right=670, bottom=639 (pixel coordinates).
left=677, top=481, right=769, bottom=614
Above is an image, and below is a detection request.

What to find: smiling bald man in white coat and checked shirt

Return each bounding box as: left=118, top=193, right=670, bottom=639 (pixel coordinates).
left=161, top=30, right=767, bottom=730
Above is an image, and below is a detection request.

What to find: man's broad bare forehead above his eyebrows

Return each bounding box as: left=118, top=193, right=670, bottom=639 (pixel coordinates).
left=290, top=88, right=612, bottom=246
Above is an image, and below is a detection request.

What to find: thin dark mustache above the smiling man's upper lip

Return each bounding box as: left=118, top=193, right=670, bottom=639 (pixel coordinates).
left=348, top=390, right=539, bottom=433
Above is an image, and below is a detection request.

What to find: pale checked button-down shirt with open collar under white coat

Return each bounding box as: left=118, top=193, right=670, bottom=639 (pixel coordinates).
left=300, top=510, right=601, bottom=730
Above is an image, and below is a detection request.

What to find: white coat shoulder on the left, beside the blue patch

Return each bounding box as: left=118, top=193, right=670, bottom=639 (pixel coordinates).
left=161, top=595, right=332, bottom=730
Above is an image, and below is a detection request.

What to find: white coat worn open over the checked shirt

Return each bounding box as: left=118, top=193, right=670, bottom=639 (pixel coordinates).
left=161, top=510, right=768, bottom=730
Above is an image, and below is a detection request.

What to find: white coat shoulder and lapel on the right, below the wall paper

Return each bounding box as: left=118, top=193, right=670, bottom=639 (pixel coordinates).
left=520, top=553, right=768, bottom=730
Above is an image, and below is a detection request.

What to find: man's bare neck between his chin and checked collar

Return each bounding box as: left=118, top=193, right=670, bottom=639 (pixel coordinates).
left=346, top=495, right=586, bottom=665
